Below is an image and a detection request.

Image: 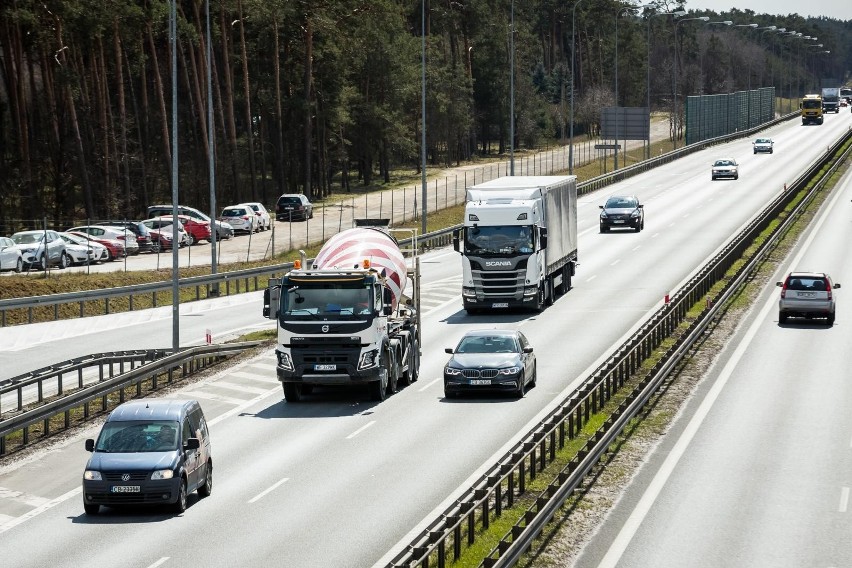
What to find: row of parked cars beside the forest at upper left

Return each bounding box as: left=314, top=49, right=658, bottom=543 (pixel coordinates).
left=0, top=194, right=313, bottom=272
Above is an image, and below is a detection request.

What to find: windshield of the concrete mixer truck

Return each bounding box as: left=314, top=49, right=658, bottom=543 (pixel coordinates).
left=281, top=281, right=374, bottom=320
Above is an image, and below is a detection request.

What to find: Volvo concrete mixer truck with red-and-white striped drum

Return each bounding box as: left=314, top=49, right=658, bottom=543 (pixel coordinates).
left=263, top=220, right=420, bottom=402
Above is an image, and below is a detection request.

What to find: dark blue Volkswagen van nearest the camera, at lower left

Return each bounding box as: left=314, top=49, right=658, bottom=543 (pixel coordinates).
left=83, top=398, right=213, bottom=515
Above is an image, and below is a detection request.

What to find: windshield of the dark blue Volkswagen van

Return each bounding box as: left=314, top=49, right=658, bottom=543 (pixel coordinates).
left=95, top=420, right=178, bottom=454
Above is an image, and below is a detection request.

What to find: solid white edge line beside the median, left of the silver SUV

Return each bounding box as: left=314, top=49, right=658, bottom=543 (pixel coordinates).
left=598, top=175, right=842, bottom=568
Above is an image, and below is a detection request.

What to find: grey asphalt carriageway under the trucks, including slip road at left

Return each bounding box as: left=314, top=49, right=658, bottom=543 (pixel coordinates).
left=0, top=114, right=852, bottom=567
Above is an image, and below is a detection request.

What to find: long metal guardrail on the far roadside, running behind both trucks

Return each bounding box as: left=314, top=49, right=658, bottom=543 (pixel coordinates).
left=0, top=113, right=798, bottom=327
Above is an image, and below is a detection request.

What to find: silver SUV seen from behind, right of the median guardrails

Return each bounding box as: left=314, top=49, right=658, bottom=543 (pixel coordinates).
left=775, top=272, right=840, bottom=325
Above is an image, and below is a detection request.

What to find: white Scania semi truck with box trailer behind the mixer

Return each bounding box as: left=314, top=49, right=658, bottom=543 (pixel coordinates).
left=453, top=176, right=577, bottom=314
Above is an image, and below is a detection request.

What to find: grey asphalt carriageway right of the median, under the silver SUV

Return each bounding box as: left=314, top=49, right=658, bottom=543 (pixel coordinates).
left=578, top=166, right=852, bottom=566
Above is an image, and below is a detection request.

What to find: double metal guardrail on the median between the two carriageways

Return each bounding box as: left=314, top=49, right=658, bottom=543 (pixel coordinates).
left=388, top=122, right=852, bottom=568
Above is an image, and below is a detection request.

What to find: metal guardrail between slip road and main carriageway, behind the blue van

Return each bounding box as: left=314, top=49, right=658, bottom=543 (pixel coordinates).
left=0, top=341, right=263, bottom=456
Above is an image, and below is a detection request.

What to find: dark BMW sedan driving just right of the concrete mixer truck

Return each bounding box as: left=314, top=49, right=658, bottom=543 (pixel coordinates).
left=444, top=329, right=536, bottom=398
